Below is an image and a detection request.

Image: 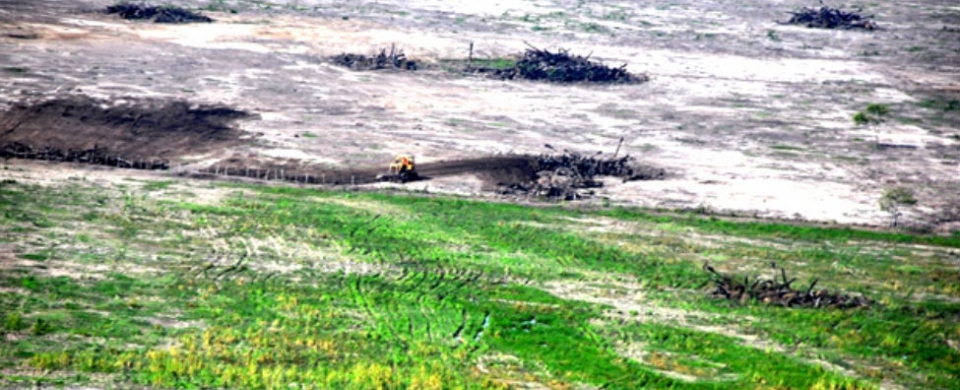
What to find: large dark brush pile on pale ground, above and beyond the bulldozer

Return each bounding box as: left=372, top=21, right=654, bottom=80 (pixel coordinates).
left=473, top=47, right=650, bottom=84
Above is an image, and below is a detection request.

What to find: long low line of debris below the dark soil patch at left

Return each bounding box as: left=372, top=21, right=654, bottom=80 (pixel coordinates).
left=0, top=142, right=170, bottom=170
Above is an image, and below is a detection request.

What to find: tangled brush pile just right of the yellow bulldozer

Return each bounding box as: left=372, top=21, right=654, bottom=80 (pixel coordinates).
left=499, top=145, right=666, bottom=200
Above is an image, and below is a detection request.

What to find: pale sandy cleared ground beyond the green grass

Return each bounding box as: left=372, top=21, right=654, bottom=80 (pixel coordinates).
left=0, top=0, right=960, bottom=231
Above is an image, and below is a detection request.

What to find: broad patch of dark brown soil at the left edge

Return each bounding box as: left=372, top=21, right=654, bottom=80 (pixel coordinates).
left=0, top=96, right=249, bottom=165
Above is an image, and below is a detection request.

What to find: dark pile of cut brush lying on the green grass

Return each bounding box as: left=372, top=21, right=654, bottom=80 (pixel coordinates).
left=703, top=263, right=873, bottom=309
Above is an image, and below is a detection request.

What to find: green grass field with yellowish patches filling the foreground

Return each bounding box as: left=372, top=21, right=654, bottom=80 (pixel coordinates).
left=0, top=179, right=960, bottom=389
